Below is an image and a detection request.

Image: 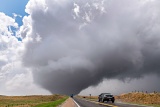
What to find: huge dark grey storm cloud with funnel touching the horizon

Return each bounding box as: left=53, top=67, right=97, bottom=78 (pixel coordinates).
left=20, top=0, right=160, bottom=94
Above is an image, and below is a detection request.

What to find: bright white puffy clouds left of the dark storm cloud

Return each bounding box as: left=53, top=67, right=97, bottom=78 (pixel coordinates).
left=0, top=12, right=49, bottom=95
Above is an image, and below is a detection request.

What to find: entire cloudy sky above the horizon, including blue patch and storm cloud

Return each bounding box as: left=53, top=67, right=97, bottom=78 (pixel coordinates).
left=0, top=0, right=160, bottom=95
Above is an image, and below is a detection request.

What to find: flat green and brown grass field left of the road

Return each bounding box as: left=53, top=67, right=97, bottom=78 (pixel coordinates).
left=0, top=95, right=68, bottom=107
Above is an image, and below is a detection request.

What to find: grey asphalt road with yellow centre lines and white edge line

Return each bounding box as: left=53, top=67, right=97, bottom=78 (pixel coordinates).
left=73, top=97, right=151, bottom=107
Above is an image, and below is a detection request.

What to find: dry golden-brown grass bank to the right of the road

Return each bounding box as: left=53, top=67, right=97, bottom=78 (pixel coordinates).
left=115, top=92, right=160, bottom=105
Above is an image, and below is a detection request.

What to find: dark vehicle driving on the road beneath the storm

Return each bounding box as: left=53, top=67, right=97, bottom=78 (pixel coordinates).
left=98, top=93, right=115, bottom=103
